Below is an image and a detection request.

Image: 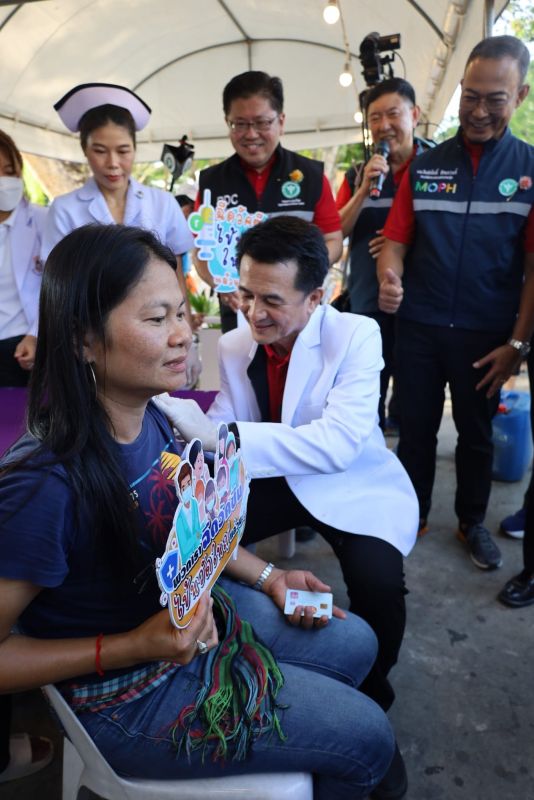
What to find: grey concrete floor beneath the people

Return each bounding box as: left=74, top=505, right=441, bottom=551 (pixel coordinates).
left=0, top=376, right=534, bottom=800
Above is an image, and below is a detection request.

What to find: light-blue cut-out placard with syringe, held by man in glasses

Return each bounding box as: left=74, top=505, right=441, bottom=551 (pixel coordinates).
left=191, top=189, right=267, bottom=294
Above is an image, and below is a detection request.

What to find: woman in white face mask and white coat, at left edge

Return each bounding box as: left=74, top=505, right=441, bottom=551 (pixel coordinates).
left=0, top=131, right=47, bottom=386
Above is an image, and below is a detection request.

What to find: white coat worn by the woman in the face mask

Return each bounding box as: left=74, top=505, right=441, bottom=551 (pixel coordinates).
left=2, top=198, right=48, bottom=336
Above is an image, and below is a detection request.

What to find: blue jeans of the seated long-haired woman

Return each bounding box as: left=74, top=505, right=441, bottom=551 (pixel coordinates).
left=80, top=579, right=394, bottom=800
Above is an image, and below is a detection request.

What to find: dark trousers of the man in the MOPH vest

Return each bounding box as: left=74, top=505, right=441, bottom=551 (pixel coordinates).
left=395, top=319, right=506, bottom=524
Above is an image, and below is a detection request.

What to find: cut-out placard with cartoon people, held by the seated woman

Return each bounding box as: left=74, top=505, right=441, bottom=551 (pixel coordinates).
left=156, top=425, right=249, bottom=628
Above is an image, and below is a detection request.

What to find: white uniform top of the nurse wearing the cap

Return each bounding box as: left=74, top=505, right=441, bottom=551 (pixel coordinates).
left=41, top=178, right=193, bottom=260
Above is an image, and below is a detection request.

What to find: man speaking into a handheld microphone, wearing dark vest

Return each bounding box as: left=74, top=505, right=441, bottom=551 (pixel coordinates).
left=336, top=78, right=429, bottom=429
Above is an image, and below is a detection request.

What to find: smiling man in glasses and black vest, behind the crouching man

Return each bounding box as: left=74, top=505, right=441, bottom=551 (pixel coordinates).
left=196, top=70, right=342, bottom=333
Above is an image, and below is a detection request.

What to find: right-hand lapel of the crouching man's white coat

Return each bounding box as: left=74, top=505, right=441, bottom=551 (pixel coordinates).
left=282, top=306, right=324, bottom=425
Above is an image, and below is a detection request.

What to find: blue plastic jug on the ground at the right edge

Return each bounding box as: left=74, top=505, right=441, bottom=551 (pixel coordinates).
left=492, top=391, right=532, bottom=481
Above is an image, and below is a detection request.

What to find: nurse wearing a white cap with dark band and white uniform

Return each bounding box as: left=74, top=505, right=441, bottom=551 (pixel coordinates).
left=42, top=83, right=200, bottom=384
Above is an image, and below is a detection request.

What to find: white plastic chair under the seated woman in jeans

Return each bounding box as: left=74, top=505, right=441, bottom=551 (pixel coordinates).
left=43, top=684, right=313, bottom=800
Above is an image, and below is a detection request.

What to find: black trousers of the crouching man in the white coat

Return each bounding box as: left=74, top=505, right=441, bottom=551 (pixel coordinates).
left=241, top=478, right=406, bottom=711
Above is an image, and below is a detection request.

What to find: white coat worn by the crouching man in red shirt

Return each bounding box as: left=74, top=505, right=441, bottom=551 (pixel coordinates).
left=208, top=306, right=419, bottom=556
